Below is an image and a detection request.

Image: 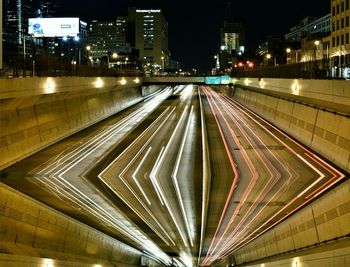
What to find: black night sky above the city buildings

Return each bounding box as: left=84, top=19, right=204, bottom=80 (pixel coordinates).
left=59, top=0, right=330, bottom=71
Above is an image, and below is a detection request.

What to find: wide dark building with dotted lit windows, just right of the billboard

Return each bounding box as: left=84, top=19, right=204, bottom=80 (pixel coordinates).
left=88, top=17, right=126, bottom=60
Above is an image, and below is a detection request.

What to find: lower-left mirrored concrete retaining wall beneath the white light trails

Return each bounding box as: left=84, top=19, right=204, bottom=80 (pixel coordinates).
left=0, top=183, right=146, bottom=266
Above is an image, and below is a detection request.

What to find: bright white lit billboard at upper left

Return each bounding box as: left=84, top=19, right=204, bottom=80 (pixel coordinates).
left=28, top=18, right=79, bottom=37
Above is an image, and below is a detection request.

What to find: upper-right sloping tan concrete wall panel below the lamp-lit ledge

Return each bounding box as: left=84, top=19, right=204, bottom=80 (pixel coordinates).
left=234, top=87, right=350, bottom=172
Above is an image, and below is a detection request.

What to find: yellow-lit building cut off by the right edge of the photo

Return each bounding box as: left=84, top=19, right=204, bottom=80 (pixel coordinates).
left=330, top=0, right=350, bottom=79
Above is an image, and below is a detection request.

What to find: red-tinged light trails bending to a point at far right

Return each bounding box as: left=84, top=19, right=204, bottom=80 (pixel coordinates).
left=202, top=88, right=345, bottom=265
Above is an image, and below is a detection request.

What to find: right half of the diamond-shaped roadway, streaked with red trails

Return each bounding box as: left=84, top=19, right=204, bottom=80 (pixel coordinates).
left=201, top=88, right=345, bottom=265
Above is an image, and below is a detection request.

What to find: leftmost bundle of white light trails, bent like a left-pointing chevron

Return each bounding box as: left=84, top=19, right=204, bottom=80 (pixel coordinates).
left=22, top=91, right=174, bottom=262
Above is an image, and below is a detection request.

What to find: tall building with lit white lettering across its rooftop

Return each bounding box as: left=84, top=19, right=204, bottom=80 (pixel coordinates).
left=128, top=8, right=170, bottom=70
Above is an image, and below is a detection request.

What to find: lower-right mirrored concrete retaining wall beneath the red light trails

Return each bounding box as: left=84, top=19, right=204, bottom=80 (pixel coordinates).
left=234, top=180, right=350, bottom=267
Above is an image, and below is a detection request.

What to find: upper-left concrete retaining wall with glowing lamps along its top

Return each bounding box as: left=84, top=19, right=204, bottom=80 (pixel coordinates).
left=0, top=77, right=142, bottom=170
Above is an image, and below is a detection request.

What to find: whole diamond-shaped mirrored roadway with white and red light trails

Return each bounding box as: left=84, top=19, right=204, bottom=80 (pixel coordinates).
left=1, top=85, right=345, bottom=265
